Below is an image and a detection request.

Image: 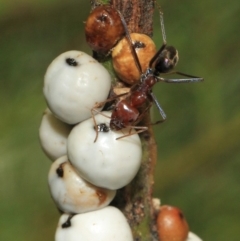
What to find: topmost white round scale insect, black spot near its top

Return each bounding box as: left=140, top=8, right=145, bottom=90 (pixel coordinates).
left=43, top=50, right=111, bottom=124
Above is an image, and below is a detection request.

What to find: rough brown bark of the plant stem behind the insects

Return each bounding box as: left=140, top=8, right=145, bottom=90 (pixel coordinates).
left=88, top=0, right=158, bottom=241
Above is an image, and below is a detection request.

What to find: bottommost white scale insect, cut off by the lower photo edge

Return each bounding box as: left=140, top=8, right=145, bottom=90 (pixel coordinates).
left=55, top=206, right=133, bottom=241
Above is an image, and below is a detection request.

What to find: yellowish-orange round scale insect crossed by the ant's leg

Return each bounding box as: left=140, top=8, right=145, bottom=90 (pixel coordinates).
left=112, top=33, right=156, bottom=85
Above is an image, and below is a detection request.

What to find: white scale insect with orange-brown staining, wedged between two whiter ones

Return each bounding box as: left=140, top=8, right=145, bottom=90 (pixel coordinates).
left=48, top=156, right=116, bottom=213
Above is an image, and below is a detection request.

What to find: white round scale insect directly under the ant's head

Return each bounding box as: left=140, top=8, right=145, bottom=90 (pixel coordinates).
left=67, top=111, right=142, bottom=190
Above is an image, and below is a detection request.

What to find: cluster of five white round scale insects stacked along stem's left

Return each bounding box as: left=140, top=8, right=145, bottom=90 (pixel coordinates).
left=39, top=51, right=142, bottom=241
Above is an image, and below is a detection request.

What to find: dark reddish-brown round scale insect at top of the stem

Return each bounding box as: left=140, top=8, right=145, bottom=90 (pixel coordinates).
left=85, top=5, right=125, bottom=54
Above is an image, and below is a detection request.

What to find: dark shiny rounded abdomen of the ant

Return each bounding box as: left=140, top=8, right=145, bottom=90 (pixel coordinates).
left=155, top=46, right=179, bottom=74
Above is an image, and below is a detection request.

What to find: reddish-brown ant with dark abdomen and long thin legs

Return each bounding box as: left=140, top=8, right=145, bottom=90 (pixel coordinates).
left=94, top=8, right=203, bottom=142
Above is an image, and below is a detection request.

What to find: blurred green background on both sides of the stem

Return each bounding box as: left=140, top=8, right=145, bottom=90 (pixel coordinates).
left=0, top=0, right=240, bottom=241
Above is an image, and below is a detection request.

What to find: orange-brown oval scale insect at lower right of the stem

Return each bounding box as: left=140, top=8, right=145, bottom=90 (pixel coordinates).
left=157, top=205, right=189, bottom=241
